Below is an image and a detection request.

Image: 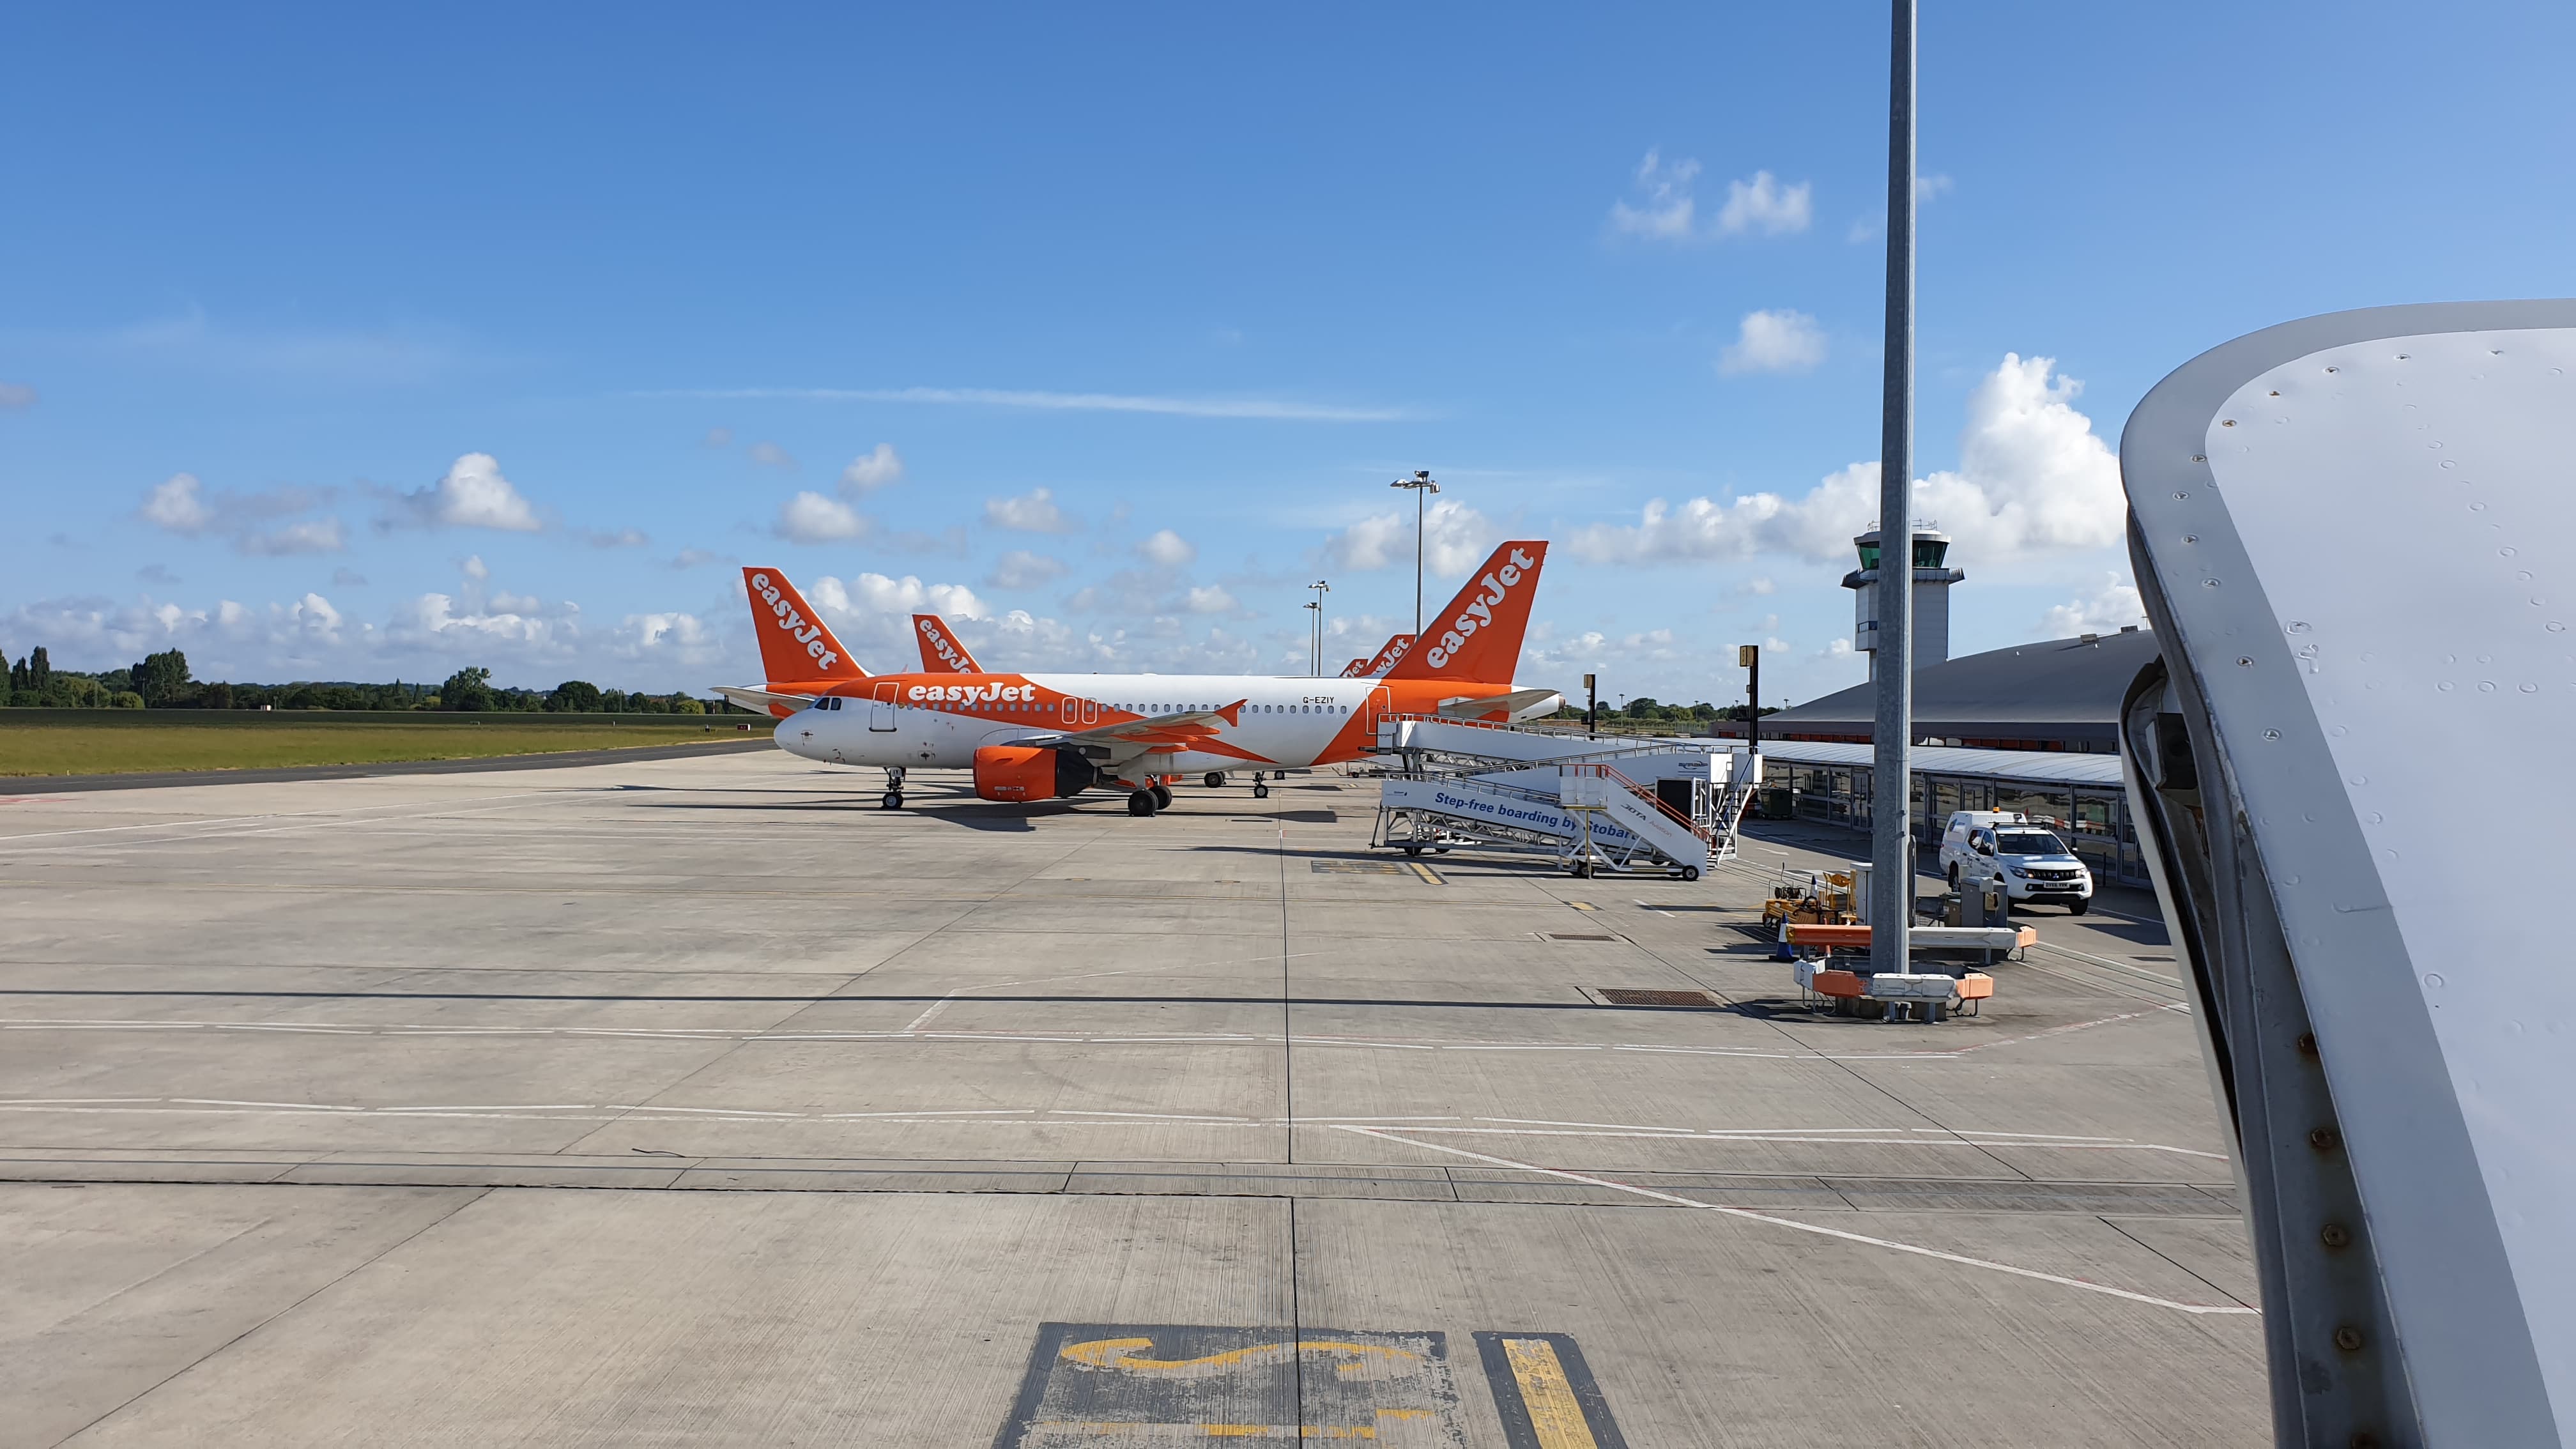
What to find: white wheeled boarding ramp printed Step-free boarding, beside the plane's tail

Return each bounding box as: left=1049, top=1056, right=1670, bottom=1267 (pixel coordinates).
left=1370, top=717, right=1759, bottom=879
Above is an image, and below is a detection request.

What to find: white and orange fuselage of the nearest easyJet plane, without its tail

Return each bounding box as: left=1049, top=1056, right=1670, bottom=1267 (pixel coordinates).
left=776, top=673, right=1393, bottom=774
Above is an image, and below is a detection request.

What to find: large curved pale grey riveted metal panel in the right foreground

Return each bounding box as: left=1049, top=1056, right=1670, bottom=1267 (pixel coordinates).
left=2120, top=302, right=2576, bottom=1446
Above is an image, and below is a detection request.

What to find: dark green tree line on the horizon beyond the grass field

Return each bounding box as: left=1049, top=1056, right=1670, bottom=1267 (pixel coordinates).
left=0, top=647, right=732, bottom=714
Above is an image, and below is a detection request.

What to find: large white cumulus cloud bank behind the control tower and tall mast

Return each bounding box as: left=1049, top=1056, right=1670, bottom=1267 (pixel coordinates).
left=1572, top=353, right=2128, bottom=562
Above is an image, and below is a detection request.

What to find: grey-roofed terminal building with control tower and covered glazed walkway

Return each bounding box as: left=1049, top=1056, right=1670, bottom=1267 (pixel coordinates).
left=1710, top=531, right=2156, bottom=887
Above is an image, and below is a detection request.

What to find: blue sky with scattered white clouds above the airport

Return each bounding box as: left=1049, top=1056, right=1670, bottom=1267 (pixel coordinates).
left=0, top=3, right=2576, bottom=699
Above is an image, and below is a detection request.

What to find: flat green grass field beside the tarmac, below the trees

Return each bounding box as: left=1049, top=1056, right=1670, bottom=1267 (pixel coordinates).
left=0, top=709, right=773, bottom=779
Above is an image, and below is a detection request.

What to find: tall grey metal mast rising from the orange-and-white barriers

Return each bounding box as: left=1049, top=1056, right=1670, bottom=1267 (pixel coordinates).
left=1870, top=0, right=1914, bottom=974
